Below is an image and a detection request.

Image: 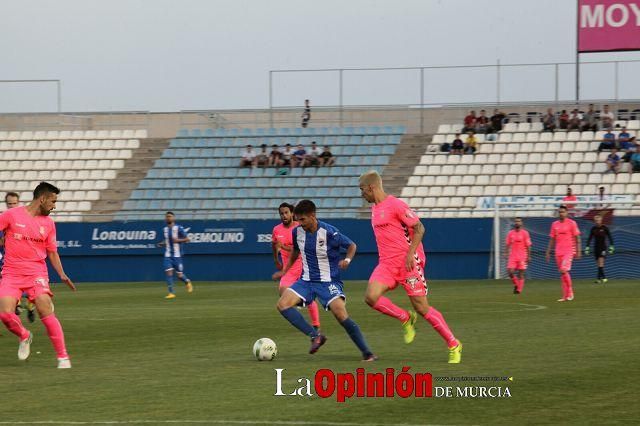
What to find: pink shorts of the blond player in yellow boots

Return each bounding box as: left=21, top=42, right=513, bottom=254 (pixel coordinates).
left=369, top=256, right=429, bottom=297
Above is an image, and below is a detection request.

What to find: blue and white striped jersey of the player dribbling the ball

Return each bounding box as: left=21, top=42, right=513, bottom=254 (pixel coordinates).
left=292, top=221, right=353, bottom=282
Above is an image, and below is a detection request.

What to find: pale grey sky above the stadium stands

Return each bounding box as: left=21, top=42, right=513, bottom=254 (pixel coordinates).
left=0, top=0, right=640, bottom=112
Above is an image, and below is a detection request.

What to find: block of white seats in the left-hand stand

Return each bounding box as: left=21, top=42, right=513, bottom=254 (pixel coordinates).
left=0, top=130, right=147, bottom=221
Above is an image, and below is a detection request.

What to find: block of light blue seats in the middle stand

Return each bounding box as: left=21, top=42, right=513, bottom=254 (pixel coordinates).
left=116, top=126, right=404, bottom=220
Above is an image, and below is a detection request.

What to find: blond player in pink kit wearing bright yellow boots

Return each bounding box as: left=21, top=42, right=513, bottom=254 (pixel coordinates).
left=360, top=171, right=462, bottom=364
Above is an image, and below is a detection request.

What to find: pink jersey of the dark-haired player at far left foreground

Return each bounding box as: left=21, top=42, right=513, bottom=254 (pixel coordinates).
left=0, top=207, right=58, bottom=277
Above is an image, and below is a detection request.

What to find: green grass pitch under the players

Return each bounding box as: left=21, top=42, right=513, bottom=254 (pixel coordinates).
left=0, top=280, right=640, bottom=425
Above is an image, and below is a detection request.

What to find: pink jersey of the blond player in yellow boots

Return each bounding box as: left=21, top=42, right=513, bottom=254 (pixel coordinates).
left=371, top=195, right=425, bottom=263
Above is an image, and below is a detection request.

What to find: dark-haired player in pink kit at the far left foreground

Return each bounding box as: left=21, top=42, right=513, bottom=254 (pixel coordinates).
left=0, top=182, right=76, bottom=368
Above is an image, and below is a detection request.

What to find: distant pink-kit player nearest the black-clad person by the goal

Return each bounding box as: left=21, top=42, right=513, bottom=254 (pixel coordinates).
left=546, top=206, right=582, bottom=302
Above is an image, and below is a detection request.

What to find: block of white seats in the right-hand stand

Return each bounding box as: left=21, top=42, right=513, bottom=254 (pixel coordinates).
left=402, top=120, right=640, bottom=217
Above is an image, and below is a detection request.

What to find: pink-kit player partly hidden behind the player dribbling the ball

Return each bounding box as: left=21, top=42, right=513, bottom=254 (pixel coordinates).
left=271, top=203, right=320, bottom=331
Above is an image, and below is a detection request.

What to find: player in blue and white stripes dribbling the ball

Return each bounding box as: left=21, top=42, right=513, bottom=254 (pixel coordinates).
left=273, top=200, right=377, bottom=361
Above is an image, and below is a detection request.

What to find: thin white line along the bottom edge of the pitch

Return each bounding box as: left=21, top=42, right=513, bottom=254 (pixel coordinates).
left=0, top=420, right=458, bottom=426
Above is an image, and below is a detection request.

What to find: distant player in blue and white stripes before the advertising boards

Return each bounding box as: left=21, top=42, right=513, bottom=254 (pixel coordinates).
left=158, top=212, right=193, bottom=299
